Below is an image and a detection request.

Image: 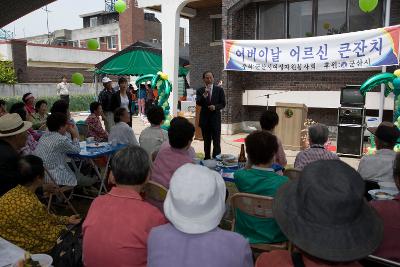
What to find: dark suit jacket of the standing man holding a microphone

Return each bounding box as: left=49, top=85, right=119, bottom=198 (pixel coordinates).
left=196, top=85, right=226, bottom=129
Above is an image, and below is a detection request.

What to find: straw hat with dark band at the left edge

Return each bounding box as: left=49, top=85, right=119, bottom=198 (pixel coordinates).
left=0, top=113, right=32, bottom=137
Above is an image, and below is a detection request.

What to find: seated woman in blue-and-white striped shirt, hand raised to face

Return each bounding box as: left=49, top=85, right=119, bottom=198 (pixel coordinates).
left=35, top=113, right=95, bottom=186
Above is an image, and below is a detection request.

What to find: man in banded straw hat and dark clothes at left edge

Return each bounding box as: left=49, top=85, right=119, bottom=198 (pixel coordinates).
left=0, top=113, right=32, bottom=196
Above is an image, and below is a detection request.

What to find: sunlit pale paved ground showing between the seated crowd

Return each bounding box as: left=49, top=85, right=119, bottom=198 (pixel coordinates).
left=73, top=113, right=360, bottom=171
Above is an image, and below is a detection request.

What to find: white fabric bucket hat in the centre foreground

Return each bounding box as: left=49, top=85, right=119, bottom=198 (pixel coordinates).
left=164, top=163, right=226, bottom=234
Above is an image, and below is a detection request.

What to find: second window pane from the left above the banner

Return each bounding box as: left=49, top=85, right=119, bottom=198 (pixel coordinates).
left=288, top=0, right=313, bottom=38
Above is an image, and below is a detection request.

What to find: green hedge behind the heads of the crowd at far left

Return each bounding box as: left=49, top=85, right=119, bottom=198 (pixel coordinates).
left=2, top=94, right=96, bottom=112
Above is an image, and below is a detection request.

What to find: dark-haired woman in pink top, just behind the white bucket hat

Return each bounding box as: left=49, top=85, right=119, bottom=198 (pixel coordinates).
left=151, top=117, right=195, bottom=188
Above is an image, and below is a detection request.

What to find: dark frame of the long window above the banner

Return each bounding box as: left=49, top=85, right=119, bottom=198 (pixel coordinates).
left=255, top=0, right=386, bottom=40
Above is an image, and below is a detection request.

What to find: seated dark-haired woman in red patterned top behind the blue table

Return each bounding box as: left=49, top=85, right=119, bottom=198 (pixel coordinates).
left=86, top=102, right=108, bottom=142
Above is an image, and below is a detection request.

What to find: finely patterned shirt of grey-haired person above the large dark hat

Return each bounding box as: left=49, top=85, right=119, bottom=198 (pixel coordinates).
left=294, top=145, right=340, bottom=170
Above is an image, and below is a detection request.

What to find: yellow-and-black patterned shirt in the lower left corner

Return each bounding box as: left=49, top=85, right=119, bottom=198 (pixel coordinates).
left=0, top=185, right=68, bottom=253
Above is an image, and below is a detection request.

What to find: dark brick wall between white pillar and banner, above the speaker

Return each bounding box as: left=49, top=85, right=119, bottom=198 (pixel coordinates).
left=189, top=7, right=223, bottom=88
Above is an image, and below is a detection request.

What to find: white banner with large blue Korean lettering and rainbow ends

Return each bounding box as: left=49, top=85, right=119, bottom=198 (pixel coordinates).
left=224, top=25, right=400, bottom=72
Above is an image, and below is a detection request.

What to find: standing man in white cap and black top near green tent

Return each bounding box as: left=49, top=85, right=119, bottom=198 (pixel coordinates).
left=99, top=77, right=115, bottom=132
